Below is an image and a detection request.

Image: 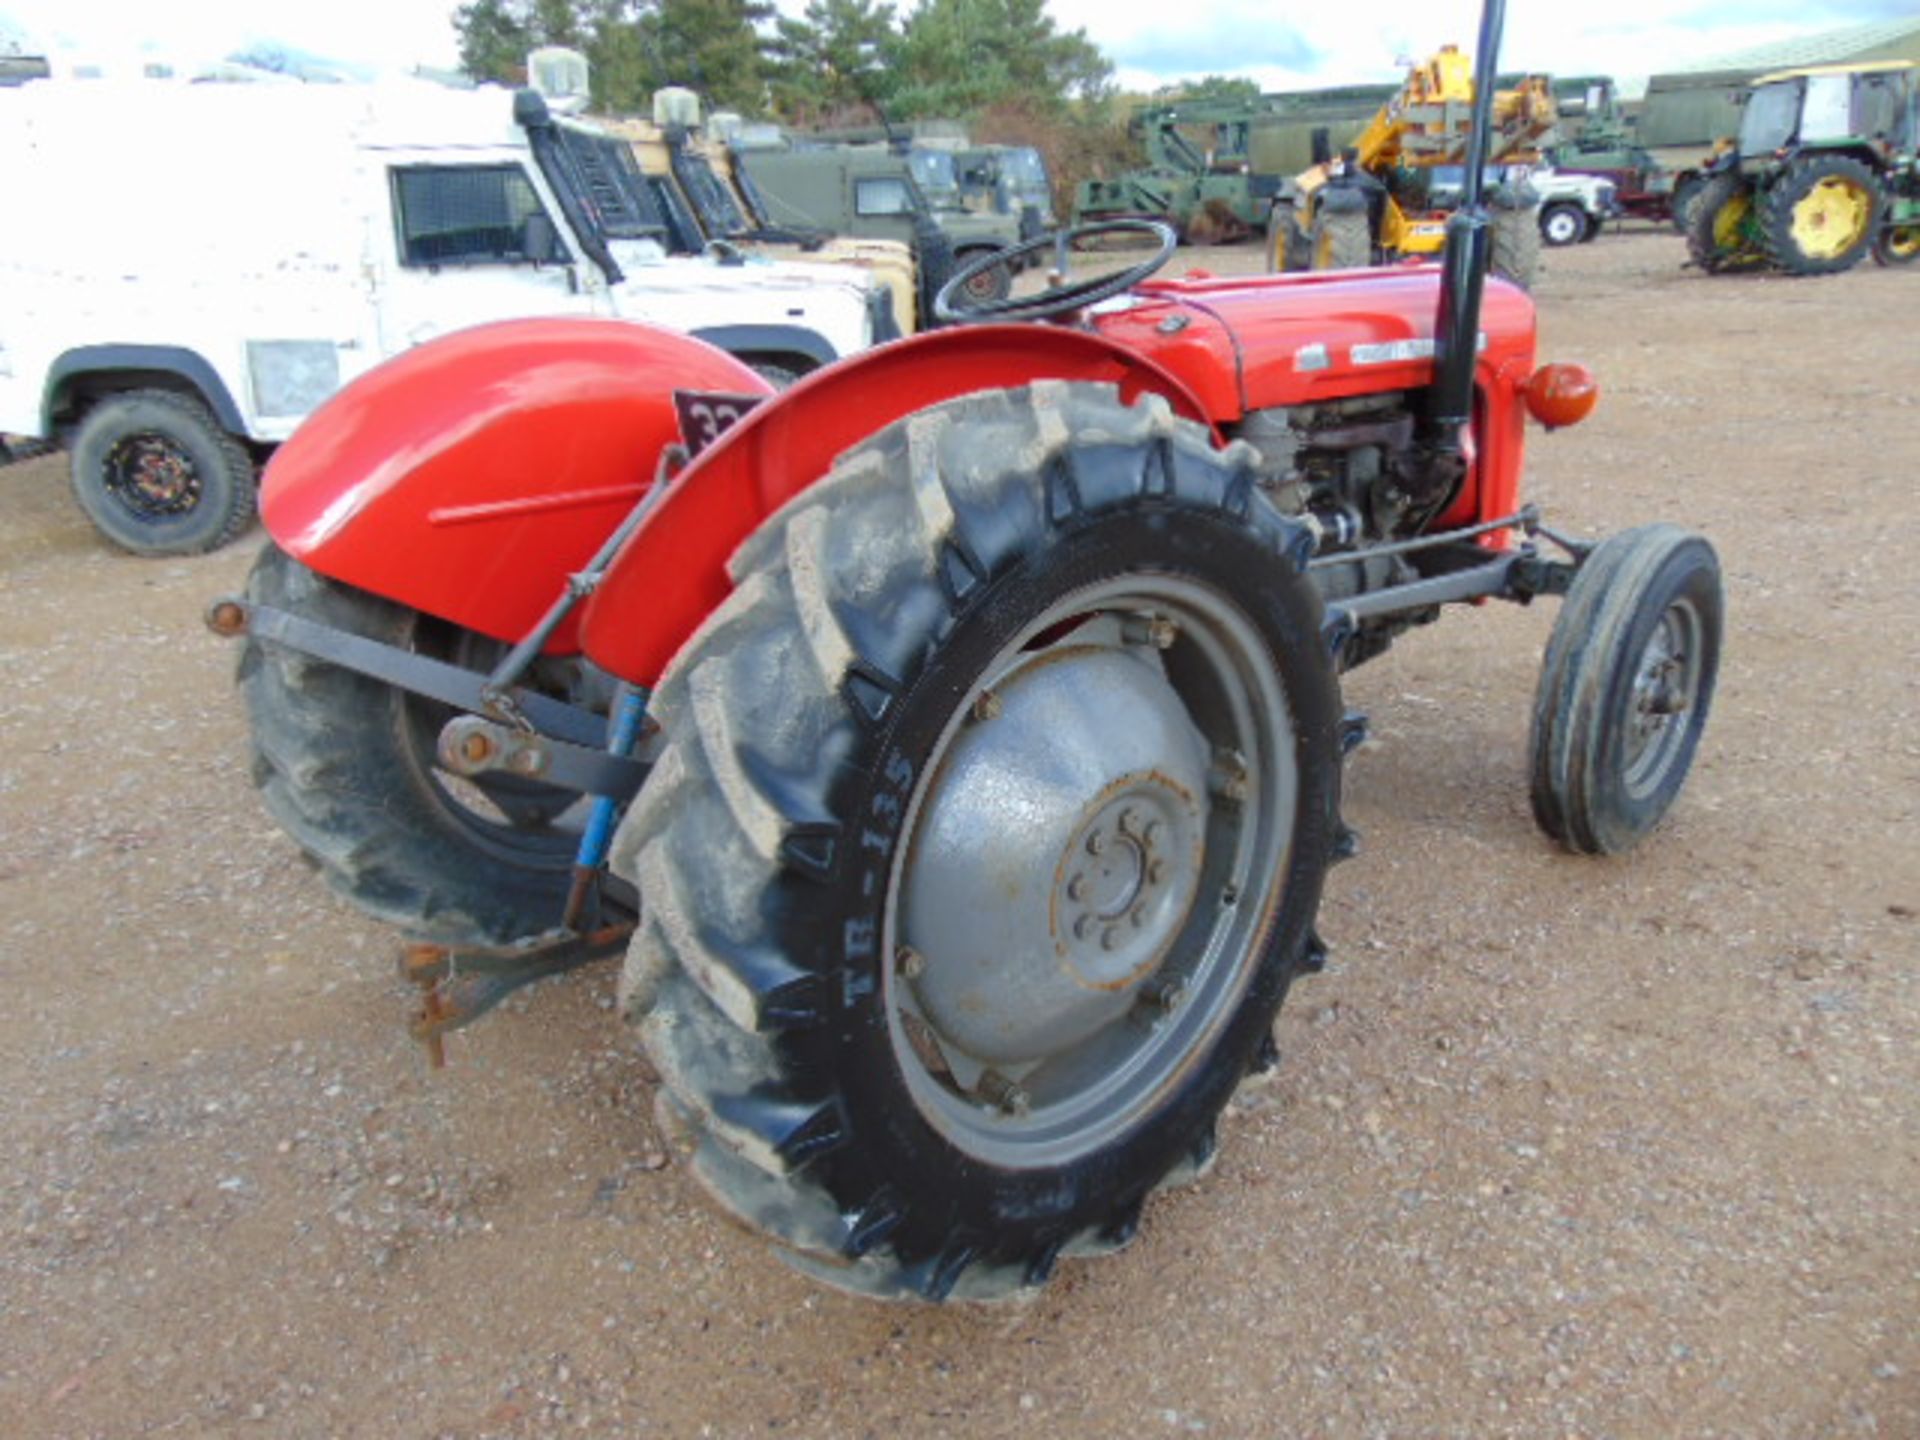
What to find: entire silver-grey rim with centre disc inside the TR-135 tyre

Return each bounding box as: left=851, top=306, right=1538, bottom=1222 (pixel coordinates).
left=885, top=576, right=1296, bottom=1169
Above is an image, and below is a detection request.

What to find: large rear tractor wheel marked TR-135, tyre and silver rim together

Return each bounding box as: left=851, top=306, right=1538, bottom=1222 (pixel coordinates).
left=612, top=382, right=1340, bottom=1300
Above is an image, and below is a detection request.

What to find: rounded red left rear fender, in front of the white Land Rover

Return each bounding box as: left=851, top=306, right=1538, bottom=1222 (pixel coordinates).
left=259, top=319, right=772, bottom=653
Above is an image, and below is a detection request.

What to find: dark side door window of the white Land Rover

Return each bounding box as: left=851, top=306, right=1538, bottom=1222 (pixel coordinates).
left=394, top=165, right=566, bottom=265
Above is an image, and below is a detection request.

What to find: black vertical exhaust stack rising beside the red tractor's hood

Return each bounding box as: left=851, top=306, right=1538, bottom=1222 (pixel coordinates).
left=1419, top=0, right=1507, bottom=474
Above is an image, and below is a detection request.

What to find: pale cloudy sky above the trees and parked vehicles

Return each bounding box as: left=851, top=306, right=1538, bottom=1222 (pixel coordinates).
left=0, top=0, right=1914, bottom=90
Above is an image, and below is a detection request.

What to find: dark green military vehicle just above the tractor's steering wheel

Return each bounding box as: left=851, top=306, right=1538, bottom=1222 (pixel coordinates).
left=741, top=146, right=1021, bottom=301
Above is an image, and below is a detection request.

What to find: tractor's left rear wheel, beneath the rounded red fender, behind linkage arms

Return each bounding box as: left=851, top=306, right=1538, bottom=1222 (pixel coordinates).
left=238, top=545, right=584, bottom=945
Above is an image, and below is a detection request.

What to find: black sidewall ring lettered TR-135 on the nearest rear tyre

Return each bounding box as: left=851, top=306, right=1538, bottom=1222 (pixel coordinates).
left=772, top=501, right=1340, bottom=1260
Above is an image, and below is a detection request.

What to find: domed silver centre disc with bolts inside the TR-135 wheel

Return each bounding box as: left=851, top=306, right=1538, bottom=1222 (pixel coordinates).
left=900, top=645, right=1208, bottom=1066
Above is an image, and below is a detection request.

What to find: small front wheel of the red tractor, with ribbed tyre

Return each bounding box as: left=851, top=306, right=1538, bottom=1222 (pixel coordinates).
left=1530, top=524, right=1724, bottom=854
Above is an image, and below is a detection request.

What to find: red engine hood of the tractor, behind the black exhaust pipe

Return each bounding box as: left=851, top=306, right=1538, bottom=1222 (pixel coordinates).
left=1094, top=265, right=1536, bottom=424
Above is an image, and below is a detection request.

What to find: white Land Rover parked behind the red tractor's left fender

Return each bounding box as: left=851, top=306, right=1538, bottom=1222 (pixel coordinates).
left=0, top=81, right=897, bottom=555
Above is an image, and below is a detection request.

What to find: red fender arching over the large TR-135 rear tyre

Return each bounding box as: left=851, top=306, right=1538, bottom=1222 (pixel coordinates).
left=580, top=324, right=1208, bottom=685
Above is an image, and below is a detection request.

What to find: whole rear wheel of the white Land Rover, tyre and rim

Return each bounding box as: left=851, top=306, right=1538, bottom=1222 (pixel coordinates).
left=73, top=390, right=255, bottom=555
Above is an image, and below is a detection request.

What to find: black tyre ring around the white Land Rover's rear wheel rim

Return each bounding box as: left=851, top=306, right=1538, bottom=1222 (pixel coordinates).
left=71, top=396, right=252, bottom=555
